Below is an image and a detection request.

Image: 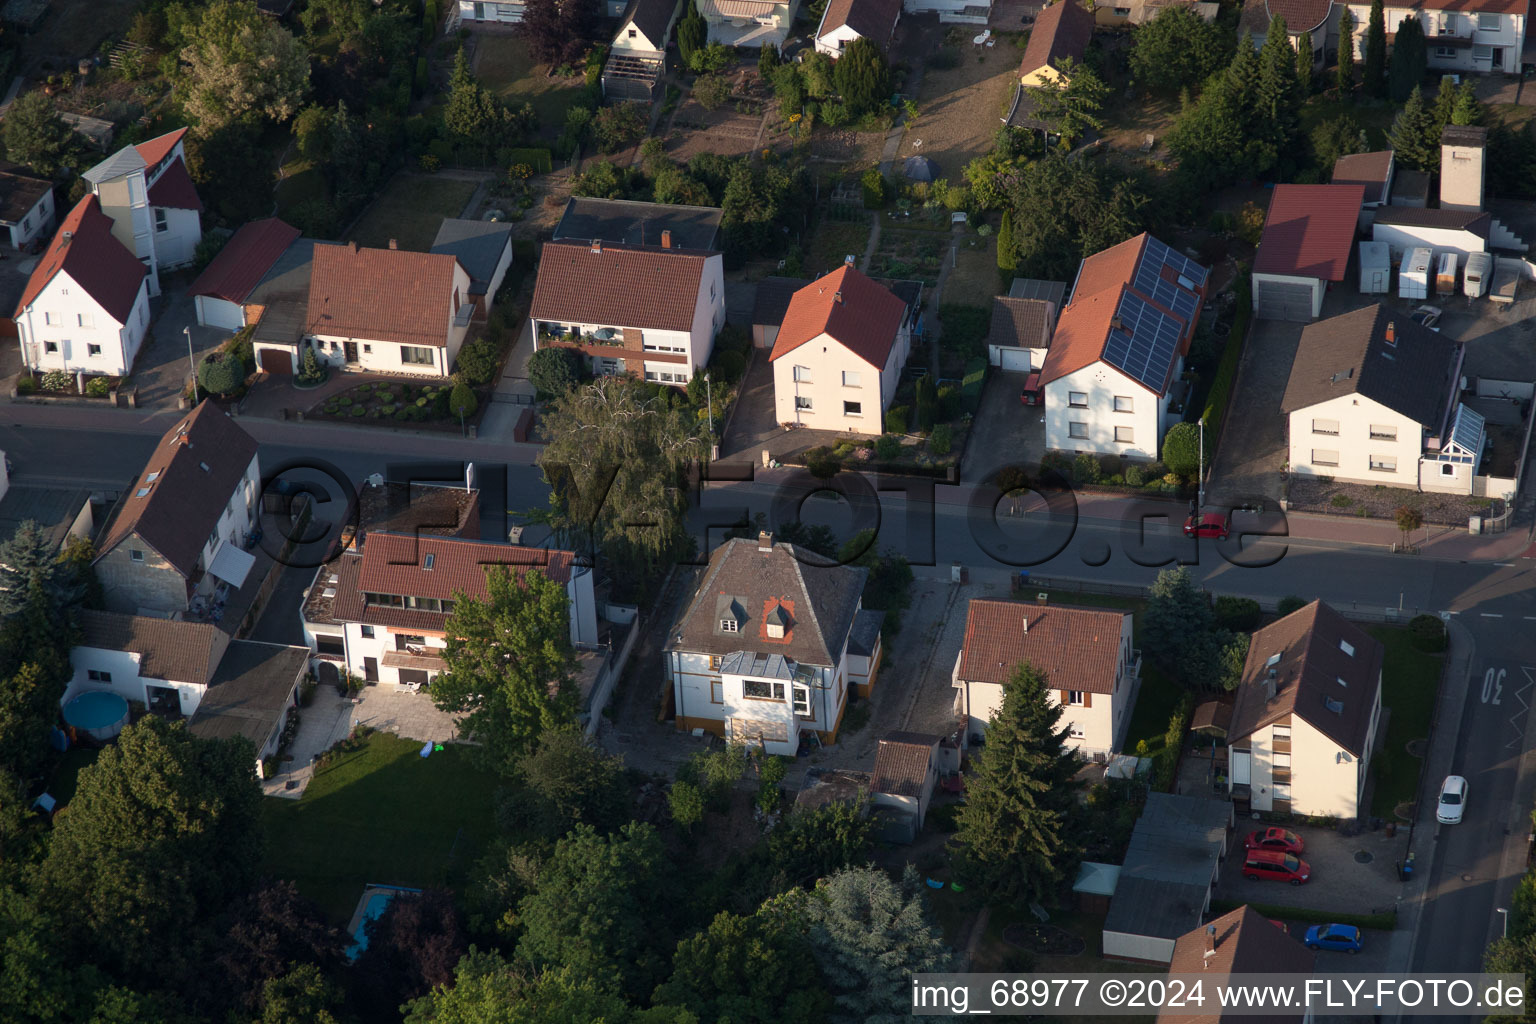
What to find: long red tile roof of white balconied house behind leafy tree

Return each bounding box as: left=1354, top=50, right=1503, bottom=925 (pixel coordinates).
left=358, top=533, right=573, bottom=599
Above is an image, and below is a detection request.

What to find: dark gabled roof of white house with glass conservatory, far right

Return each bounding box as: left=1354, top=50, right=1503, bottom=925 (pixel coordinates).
left=1279, top=304, right=1461, bottom=430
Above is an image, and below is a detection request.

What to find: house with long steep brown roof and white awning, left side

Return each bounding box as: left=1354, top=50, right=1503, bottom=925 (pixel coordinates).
left=95, top=402, right=261, bottom=614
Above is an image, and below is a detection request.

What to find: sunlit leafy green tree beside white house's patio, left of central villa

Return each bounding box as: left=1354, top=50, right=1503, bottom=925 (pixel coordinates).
left=432, top=565, right=576, bottom=774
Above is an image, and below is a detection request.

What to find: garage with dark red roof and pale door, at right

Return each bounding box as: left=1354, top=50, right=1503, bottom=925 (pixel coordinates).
left=1253, top=184, right=1366, bottom=321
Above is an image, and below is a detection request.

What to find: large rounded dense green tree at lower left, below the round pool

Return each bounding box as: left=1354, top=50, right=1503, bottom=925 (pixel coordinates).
left=38, top=715, right=263, bottom=976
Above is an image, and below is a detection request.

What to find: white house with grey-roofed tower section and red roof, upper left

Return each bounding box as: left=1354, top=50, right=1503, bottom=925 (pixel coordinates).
left=80, top=127, right=203, bottom=295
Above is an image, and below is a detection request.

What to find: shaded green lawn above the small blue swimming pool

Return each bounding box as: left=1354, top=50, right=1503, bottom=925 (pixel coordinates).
left=263, top=732, right=499, bottom=923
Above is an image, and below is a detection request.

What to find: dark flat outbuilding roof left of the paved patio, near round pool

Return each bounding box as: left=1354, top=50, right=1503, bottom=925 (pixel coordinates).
left=187, top=640, right=310, bottom=751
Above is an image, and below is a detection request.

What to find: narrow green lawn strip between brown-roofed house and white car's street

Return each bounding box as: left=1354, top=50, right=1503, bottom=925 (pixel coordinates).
left=1369, top=626, right=1445, bottom=821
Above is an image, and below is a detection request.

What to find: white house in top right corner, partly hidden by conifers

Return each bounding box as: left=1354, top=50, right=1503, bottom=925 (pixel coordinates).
left=1341, top=0, right=1528, bottom=72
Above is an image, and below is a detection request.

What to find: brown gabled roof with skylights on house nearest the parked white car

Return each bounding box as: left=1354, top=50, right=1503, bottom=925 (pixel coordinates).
left=1227, top=600, right=1384, bottom=757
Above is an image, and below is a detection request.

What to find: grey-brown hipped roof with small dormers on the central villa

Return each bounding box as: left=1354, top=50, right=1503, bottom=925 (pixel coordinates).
left=667, top=537, right=869, bottom=666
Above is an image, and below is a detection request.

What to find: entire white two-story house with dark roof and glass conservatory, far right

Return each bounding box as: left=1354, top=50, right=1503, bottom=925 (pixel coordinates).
left=1279, top=306, right=1487, bottom=494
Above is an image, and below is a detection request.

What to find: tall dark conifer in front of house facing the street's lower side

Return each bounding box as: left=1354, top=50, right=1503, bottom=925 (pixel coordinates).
left=955, top=662, right=1081, bottom=904
